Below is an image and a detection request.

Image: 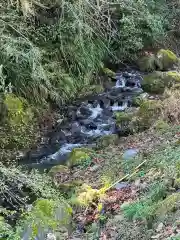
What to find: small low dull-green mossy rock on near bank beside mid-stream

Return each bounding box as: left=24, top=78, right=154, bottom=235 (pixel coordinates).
left=96, top=134, right=119, bottom=149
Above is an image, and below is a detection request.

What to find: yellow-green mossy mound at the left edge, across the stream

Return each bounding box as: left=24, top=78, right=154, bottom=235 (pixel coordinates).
left=0, top=94, right=37, bottom=149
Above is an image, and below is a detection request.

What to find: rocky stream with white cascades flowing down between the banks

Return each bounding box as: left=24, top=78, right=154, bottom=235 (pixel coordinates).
left=21, top=69, right=143, bottom=170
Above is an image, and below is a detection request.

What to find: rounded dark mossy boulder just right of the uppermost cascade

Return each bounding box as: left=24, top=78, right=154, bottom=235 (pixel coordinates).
left=141, top=71, right=166, bottom=94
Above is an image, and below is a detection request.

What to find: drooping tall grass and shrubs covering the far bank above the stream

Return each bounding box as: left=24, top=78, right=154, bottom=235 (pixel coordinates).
left=0, top=0, right=176, bottom=103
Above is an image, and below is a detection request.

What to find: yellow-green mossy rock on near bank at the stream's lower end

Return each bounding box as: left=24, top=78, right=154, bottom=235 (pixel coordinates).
left=67, top=148, right=91, bottom=167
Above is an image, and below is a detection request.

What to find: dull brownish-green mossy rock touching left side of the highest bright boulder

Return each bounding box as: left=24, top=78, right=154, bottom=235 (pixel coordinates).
left=138, top=54, right=156, bottom=72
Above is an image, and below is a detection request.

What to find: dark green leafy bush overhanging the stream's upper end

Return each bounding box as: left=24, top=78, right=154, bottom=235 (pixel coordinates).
left=109, top=0, right=168, bottom=60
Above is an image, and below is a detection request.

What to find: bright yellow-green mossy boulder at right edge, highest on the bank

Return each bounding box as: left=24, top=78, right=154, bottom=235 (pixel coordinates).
left=157, top=49, right=178, bottom=70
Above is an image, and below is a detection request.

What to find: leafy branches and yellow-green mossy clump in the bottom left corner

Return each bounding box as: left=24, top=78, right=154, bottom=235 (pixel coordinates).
left=0, top=165, right=72, bottom=240
